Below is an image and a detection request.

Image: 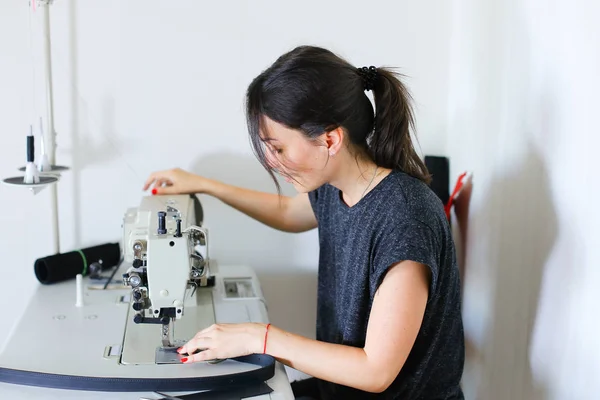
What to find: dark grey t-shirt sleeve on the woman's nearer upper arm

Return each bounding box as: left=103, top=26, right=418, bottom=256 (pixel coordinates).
left=371, top=219, right=440, bottom=298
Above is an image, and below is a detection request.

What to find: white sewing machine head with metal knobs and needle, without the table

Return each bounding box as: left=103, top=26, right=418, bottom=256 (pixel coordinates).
left=121, top=196, right=216, bottom=364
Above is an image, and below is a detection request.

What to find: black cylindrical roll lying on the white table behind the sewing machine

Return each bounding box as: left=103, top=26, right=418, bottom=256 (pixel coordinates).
left=33, top=243, right=121, bottom=285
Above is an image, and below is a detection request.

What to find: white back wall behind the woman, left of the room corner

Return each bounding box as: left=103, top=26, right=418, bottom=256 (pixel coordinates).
left=0, top=0, right=451, bottom=384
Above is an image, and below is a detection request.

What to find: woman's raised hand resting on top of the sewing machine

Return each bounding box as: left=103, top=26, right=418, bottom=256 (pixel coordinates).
left=143, top=168, right=210, bottom=194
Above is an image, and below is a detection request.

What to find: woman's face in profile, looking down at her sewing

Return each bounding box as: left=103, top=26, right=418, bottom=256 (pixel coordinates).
left=261, top=118, right=331, bottom=193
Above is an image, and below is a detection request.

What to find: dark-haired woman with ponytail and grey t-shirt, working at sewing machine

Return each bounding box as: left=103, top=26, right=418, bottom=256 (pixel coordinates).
left=144, top=46, right=464, bottom=400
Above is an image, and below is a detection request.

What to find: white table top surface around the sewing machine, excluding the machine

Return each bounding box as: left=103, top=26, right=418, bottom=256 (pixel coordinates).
left=0, top=266, right=294, bottom=400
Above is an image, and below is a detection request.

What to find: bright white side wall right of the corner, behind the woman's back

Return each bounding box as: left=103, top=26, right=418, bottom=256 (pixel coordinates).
left=447, top=0, right=600, bottom=400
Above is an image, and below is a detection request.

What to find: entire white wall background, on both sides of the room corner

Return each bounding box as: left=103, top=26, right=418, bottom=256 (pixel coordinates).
left=7, top=0, right=600, bottom=400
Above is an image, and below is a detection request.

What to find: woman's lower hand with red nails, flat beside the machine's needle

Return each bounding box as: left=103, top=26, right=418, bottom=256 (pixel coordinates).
left=177, top=323, right=266, bottom=363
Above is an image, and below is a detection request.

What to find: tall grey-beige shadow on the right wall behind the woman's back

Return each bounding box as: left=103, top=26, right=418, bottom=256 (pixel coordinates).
left=467, top=146, right=557, bottom=400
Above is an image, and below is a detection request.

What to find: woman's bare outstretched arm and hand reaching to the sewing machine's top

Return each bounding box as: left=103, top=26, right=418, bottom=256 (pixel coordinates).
left=144, top=169, right=317, bottom=232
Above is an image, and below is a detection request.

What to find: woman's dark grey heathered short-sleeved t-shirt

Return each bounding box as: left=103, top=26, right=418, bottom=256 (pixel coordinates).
left=309, top=171, right=465, bottom=400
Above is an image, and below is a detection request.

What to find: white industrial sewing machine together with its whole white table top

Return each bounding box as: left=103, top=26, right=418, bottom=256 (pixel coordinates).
left=0, top=195, right=294, bottom=400
